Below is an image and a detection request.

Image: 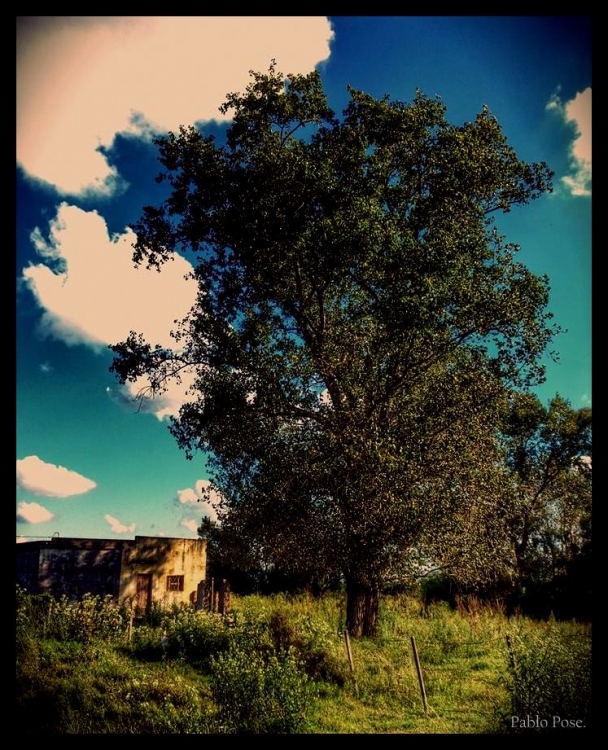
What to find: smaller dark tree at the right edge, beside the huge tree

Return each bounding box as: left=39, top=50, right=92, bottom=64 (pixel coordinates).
left=501, top=393, right=592, bottom=609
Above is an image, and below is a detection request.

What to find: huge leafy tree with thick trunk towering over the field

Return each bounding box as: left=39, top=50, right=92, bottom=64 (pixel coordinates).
left=111, top=63, right=553, bottom=636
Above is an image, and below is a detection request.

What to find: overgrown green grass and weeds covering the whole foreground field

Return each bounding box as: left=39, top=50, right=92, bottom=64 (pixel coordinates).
left=15, top=589, right=591, bottom=735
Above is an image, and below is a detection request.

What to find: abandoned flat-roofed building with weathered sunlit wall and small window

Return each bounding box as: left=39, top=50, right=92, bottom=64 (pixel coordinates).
left=16, top=536, right=207, bottom=613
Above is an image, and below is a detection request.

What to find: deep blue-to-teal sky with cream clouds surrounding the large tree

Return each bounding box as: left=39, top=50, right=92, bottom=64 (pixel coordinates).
left=16, top=16, right=591, bottom=539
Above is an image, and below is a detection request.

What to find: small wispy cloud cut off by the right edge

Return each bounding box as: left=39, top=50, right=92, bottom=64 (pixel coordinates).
left=547, top=87, right=591, bottom=196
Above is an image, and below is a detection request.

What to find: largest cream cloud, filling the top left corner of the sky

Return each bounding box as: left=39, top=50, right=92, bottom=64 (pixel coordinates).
left=17, top=16, right=333, bottom=195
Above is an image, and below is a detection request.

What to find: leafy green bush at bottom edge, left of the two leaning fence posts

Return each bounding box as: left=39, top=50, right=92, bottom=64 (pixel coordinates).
left=211, top=645, right=312, bottom=734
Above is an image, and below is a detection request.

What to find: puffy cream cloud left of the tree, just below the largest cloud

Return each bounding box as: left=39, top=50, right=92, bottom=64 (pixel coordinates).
left=22, top=203, right=197, bottom=347
